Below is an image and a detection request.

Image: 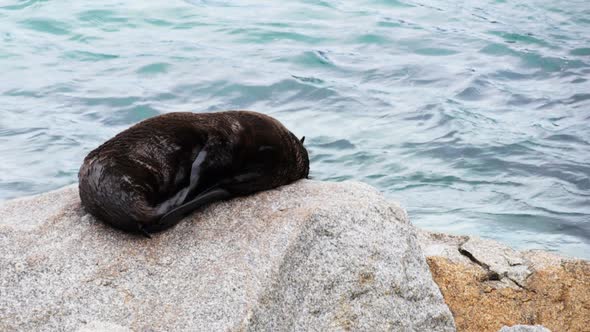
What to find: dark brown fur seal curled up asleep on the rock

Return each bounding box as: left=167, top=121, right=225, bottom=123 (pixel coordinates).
left=78, top=111, right=309, bottom=236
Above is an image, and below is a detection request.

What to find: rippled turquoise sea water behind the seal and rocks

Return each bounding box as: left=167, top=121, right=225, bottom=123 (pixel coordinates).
left=0, top=0, right=590, bottom=258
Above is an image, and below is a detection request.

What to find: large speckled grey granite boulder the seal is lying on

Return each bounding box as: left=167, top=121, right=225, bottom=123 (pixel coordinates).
left=0, top=181, right=454, bottom=331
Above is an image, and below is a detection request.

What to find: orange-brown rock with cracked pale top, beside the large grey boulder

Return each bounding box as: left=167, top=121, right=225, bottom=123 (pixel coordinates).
left=419, top=231, right=590, bottom=332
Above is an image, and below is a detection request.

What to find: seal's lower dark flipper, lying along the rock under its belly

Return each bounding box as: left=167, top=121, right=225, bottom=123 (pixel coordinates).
left=144, top=188, right=231, bottom=233
